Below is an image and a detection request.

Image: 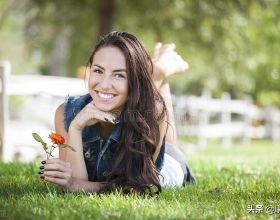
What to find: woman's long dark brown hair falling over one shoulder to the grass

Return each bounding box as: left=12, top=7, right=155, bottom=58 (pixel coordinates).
left=89, top=31, right=166, bottom=194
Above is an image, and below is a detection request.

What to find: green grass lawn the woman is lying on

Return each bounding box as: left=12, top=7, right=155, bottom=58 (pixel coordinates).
left=0, top=142, right=280, bottom=220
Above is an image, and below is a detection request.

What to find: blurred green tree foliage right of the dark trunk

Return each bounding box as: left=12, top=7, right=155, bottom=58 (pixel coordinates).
left=115, top=0, right=280, bottom=104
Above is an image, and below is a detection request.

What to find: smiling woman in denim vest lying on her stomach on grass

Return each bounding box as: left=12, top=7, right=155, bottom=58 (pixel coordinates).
left=39, top=32, right=194, bottom=193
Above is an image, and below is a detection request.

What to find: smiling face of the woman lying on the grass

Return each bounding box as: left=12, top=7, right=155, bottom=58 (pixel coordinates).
left=88, top=46, right=128, bottom=112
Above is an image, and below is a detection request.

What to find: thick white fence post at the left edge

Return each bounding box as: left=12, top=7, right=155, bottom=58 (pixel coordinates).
left=0, top=61, right=11, bottom=162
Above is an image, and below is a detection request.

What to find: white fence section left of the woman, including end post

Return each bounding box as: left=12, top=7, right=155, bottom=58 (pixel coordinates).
left=0, top=62, right=86, bottom=162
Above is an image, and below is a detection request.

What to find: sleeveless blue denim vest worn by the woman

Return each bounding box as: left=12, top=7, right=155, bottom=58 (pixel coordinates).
left=64, top=94, right=165, bottom=181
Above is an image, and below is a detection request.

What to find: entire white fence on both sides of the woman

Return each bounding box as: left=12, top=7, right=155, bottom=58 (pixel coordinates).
left=0, top=62, right=280, bottom=161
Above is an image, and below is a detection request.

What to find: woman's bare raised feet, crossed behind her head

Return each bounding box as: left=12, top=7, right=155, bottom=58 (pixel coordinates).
left=153, top=43, right=189, bottom=80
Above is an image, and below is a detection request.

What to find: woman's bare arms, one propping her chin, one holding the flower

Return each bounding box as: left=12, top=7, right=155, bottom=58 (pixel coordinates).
left=42, top=103, right=114, bottom=192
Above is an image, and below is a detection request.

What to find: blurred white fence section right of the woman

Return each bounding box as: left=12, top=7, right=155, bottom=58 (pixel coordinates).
left=173, top=92, right=280, bottom=146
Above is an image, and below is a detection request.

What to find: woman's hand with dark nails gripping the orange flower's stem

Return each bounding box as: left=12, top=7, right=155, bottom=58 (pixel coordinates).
left=39, top=158, right=73, bottom=188
